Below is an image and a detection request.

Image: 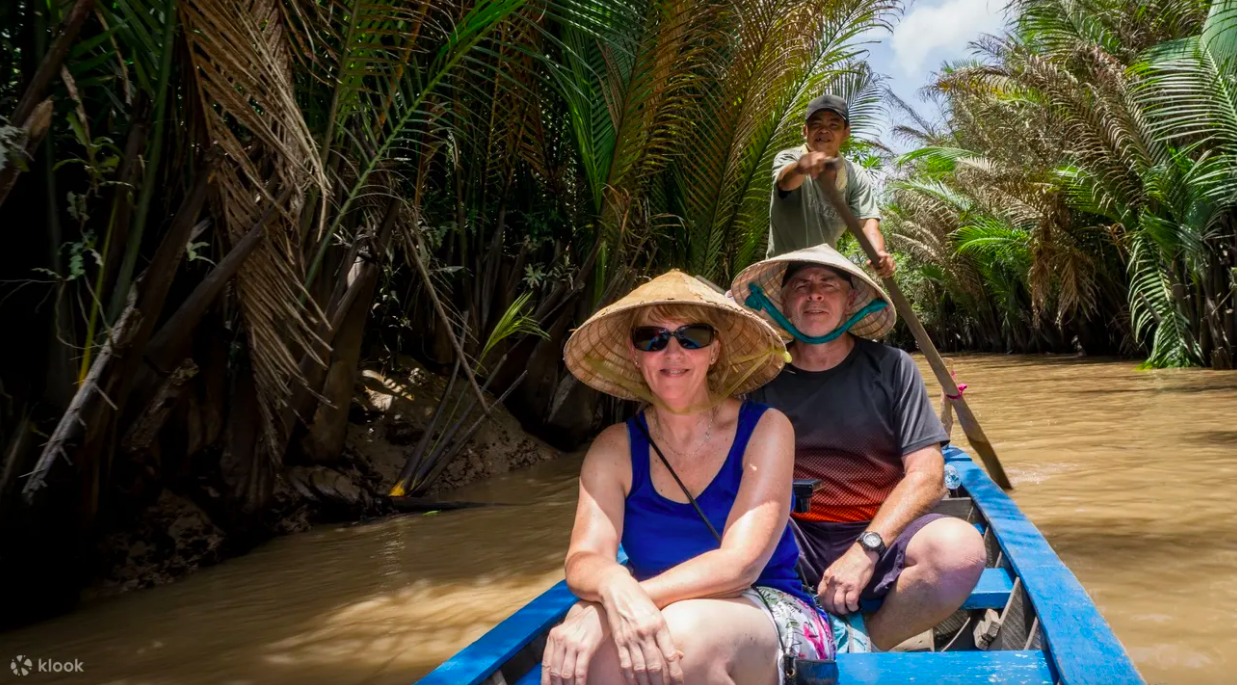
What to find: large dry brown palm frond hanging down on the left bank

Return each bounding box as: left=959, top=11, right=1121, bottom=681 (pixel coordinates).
left=182, top=0, right=327, bottom=459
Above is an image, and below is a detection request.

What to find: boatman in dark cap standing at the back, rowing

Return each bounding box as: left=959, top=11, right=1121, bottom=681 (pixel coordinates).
left=764, top=94, right=894, bottom=277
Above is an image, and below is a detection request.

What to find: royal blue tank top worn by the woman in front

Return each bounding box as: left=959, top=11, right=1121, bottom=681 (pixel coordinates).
left=622, top=402, right=814, bottom=606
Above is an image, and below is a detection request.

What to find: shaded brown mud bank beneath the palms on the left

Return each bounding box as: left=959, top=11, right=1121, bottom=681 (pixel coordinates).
left=80, top=356, right=559, bottom=600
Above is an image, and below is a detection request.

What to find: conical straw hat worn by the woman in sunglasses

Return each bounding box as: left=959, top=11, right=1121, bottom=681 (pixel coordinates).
left=563, top=270, right=787, bottom=402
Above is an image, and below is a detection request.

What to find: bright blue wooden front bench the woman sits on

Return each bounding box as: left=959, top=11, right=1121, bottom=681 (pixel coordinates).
left=516, top=649, right=1055, bottom=685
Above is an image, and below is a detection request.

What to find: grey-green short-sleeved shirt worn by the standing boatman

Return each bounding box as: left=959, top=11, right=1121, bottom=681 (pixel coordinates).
left=764, top=146, right=881, bottom=258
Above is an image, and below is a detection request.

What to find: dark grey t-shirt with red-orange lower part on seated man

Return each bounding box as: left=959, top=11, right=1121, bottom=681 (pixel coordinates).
left=748, top=339, right=949, bottom=522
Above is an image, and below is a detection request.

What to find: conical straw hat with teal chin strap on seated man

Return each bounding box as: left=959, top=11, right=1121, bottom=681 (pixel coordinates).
left=730, top=244, right=897, bottom=340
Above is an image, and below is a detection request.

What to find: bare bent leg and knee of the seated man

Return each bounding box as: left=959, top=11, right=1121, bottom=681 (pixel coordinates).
left=867, top=518, right=987, bottom=650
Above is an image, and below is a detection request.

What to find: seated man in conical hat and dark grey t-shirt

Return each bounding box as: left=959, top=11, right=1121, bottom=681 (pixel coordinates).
left=732, top=245, right=986, bottom=649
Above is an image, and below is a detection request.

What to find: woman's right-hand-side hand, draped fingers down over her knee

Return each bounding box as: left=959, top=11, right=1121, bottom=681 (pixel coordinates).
left=601, top=574, right=683, bottom=685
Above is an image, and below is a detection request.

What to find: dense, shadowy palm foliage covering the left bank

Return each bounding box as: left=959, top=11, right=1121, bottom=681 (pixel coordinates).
left=0, top=0, right=897, bottom=620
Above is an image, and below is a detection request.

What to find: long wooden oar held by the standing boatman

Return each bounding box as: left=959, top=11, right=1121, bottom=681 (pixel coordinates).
left=820, top=173, right=1013, bottom=490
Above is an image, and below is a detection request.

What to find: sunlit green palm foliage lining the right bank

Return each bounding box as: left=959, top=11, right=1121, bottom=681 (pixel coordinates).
left=889, top=0, right=1237, bottom=367
